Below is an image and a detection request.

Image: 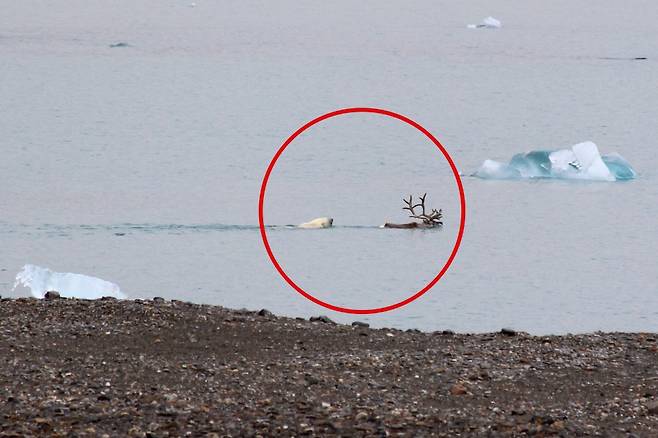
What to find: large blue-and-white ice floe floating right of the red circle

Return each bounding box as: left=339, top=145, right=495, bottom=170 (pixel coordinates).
left=473, top=141, right=636, bottom=181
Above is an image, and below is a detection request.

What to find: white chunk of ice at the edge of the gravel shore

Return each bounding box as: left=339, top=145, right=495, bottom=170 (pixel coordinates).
left=14, top=265, right=126, bottom=300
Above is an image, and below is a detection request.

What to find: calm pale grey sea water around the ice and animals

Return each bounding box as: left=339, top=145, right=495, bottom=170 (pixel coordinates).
left=0, top=0, right=658, bottom=333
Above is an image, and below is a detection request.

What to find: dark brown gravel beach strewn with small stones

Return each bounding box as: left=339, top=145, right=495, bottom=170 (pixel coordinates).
left=0, top=298, right=658, bottom=437
